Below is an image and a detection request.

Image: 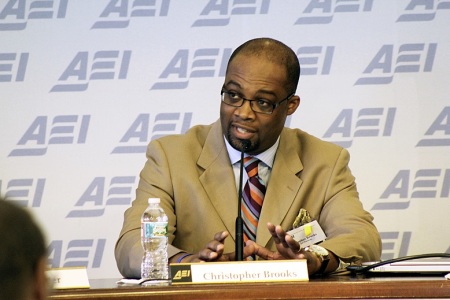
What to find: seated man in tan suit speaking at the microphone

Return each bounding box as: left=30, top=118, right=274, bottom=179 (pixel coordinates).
left=115, top=38, right=381, bottom=278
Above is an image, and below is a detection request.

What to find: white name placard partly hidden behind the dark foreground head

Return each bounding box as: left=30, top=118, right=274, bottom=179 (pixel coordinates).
left=47, top=267, right=90, bottom=290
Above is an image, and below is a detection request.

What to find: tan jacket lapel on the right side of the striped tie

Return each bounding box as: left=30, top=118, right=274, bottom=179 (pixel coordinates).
left=256, top=130, right=303, bottom=246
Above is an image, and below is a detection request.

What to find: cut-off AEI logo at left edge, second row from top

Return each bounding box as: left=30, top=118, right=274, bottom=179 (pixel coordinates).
left=0, top=53, right=30, bottom=82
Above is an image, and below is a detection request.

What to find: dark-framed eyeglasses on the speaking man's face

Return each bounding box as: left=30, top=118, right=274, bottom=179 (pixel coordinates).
left=220, top=90, right=294, bottom=115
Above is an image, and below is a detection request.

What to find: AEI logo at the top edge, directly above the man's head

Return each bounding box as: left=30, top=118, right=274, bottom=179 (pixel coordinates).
left=192, top=0, right=270, bottom=27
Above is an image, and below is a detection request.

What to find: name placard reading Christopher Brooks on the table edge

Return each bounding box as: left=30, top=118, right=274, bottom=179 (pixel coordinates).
left=170, top=259, right=309, bottom=284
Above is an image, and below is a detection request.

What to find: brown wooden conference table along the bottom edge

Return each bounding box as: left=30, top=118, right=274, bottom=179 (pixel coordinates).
left=50, top=275, right=450, bottom=300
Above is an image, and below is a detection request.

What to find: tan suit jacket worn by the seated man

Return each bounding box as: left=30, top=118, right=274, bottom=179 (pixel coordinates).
left=115, top=121, right=381, bottom=277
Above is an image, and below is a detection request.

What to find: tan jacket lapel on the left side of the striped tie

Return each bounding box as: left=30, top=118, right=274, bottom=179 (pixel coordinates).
left=197, top=122, right=238, bottom=239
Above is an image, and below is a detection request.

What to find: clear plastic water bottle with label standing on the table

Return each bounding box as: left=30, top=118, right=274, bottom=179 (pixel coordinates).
left=141, top=198, right=169, bottom=281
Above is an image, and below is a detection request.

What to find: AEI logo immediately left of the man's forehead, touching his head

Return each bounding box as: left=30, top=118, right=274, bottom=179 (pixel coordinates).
left=151, top=48, right=231, bottom=90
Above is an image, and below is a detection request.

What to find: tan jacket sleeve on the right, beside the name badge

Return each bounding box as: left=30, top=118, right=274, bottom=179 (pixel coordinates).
left=318, top=149, right=381, bottom=262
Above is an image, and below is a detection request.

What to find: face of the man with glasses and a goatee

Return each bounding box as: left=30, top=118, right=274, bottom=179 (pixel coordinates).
left=220, top=55, right=300, bottom=155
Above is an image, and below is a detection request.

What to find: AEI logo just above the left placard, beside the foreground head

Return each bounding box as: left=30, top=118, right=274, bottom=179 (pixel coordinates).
left=47, top=239, right=106, bottom=269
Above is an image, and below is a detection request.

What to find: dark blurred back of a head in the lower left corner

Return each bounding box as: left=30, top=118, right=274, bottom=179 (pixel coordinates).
left=0, top=199, right=47, bottom=300
